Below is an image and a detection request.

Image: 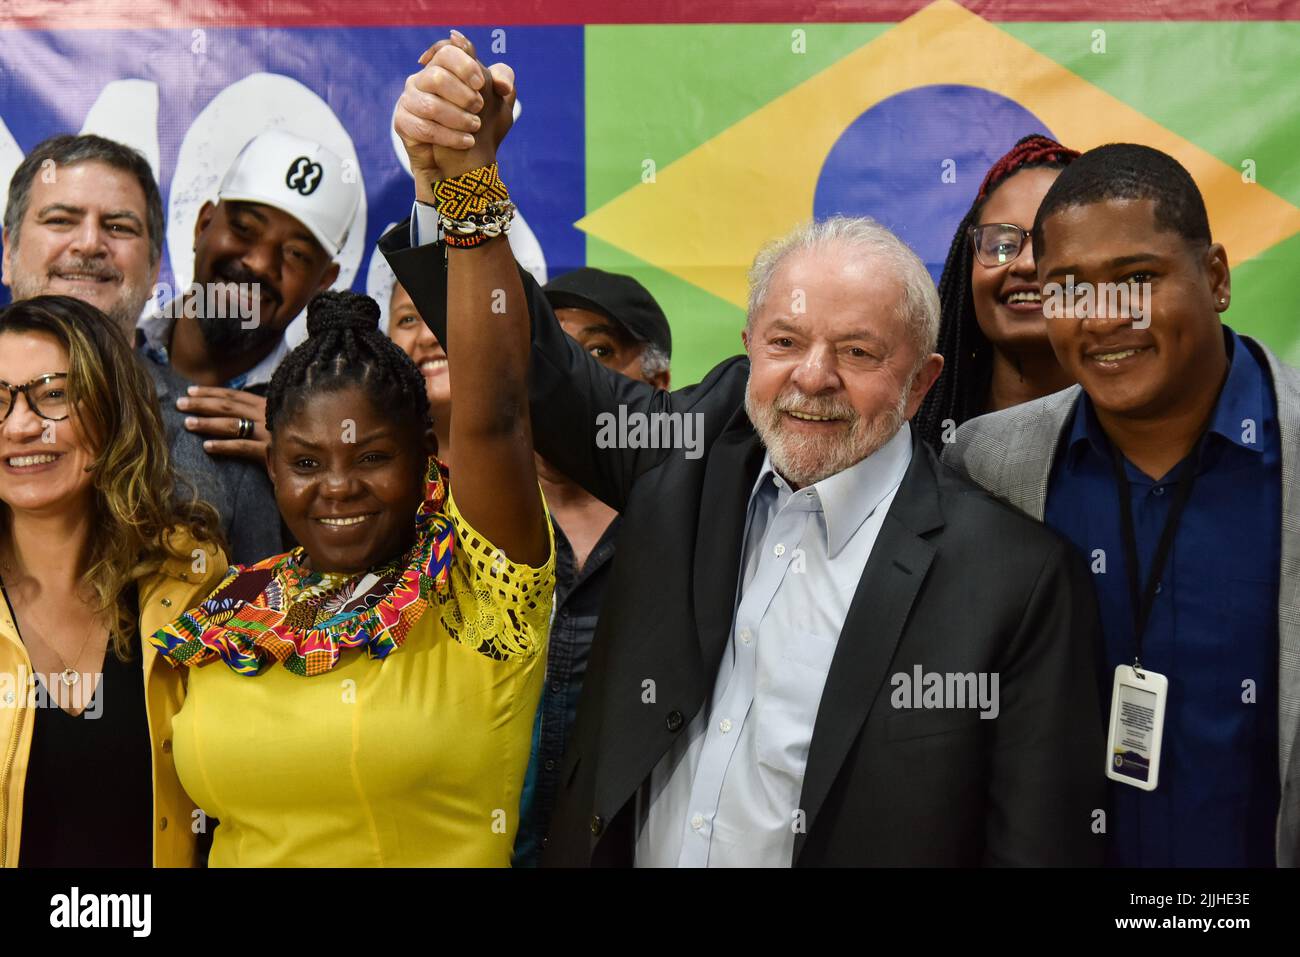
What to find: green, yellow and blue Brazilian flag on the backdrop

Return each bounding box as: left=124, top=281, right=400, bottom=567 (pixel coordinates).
left=582, top=0, right=1300, bottom=382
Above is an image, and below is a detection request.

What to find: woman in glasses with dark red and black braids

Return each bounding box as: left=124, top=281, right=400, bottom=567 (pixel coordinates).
left=913, top=134, right=1079, bottom=450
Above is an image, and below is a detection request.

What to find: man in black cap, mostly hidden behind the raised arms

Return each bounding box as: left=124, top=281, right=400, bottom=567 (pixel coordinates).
left=515, top=268, right=672, bottom=867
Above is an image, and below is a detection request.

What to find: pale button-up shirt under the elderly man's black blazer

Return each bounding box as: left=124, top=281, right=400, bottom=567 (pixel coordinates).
left=636, top=424, right=911, bottom=867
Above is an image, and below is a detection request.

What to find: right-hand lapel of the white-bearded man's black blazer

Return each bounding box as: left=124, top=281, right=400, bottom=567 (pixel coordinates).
left=794, top=441, right=944, bottom=861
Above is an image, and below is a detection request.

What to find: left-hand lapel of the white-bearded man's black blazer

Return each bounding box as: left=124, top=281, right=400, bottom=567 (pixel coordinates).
left=694, top=411, right=763, bottom=670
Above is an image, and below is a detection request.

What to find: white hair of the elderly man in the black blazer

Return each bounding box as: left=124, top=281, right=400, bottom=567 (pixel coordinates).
left=745, top=216, right=939, bottom=364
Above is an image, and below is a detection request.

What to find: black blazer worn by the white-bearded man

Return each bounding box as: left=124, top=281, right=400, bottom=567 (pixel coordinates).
left=381, top=224, right=1105, bottom=866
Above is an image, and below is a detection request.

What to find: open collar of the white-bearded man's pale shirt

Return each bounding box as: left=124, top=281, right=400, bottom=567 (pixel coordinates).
left=750, top=423, right=911, bottom=558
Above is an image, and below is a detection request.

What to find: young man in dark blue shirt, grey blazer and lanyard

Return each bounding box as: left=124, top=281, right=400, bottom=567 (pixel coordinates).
left=944, top=144, right=1300, bottom=867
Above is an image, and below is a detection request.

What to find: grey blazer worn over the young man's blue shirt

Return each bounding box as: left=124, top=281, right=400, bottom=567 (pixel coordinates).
left=944, top=335, right=1300, bottom=867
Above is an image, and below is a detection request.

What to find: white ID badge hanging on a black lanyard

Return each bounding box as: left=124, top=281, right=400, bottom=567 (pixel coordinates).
left=1106, top=664, right=1169, bottom=791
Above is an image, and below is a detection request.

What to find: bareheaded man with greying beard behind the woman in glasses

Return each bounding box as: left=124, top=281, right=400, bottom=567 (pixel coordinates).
left=4, top=134, right=283, bottom=562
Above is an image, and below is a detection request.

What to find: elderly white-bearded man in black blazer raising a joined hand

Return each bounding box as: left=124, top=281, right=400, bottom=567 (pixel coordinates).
left=381, top=35, right=1105, bottom=866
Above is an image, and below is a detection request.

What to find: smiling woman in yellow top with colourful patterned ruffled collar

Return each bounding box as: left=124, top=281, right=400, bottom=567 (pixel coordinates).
left=152, top=286, right=555, bottom=866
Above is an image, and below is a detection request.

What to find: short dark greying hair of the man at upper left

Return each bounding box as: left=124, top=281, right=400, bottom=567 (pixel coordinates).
left=4, top=133, right=163, bottom=265
